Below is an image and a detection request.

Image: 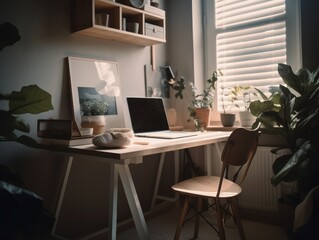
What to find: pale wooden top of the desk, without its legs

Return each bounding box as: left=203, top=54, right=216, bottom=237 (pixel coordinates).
left=42, top=131, right=231, bottom=163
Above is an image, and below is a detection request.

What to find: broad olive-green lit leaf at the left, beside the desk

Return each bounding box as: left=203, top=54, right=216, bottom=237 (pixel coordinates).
left=9, top=85, right=53, bottom=114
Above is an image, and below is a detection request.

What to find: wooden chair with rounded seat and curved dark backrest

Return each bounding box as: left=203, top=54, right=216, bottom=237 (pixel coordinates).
left=172, top=126, right=259, bottom=240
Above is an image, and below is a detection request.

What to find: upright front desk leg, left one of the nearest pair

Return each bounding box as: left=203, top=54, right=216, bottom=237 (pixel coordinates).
left=108, top=164, right=119, bottom=240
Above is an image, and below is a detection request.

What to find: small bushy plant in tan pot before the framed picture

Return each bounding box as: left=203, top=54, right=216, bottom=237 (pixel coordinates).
left=80, top=98, right=109, bottom=135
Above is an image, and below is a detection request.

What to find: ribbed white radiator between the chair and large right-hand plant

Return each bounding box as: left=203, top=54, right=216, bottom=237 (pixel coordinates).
left=239, top=147, right=281, bottom=211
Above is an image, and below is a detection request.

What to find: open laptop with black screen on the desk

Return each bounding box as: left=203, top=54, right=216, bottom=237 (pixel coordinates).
left=126, top=97, right=198, bottom=139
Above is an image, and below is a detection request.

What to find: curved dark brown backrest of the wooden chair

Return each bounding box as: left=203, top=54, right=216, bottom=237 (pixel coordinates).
left=221, top=125, right=260, bottom=187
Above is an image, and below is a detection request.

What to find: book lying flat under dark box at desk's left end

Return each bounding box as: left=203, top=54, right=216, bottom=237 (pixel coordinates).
left=39, top=136, right=93, bottom=146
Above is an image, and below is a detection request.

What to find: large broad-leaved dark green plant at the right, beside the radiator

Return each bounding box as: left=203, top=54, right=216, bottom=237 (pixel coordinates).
left=250, top=64, right=319, bottom=239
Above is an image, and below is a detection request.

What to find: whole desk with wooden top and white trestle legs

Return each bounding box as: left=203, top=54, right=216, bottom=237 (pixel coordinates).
left=44, top=131, right=231, bottom=240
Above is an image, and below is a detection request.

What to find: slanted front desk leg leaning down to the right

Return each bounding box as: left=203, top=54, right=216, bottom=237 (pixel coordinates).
left=114, top=164, right=150, bottom=240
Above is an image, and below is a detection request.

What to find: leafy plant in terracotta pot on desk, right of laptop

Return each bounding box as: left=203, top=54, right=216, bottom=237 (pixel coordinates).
left=188, top=71, right=218, bottom=131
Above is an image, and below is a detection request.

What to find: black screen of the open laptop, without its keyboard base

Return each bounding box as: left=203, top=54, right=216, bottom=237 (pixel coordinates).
left=127, top=97, right=169, bottom=133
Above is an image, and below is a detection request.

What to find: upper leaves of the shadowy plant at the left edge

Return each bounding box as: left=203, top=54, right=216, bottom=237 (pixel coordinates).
left=0, top=22, right=53, bottom=146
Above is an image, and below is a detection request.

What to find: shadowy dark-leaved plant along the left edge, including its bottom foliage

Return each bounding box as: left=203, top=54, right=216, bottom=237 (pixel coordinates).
left=0, top=22, right=54, bottom=239
